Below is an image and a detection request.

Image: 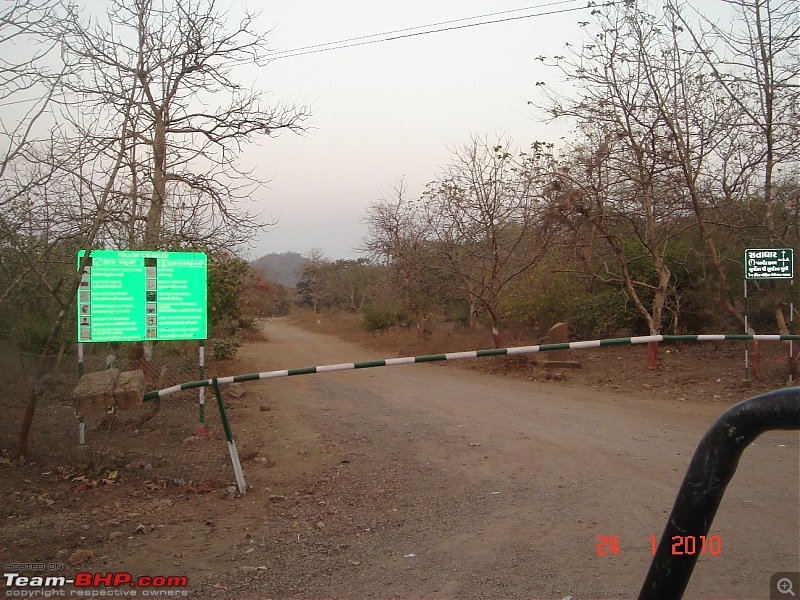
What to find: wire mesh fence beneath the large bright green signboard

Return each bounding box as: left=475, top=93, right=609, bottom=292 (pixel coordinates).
left=0, top=344, right=234, bottom=488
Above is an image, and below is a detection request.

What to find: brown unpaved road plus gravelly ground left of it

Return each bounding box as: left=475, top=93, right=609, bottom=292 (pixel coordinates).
left=0, top=319, right=800, bottom=600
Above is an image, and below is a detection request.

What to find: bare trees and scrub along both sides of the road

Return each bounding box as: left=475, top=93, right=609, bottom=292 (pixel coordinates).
left=0, top=0, right=800, bottom=368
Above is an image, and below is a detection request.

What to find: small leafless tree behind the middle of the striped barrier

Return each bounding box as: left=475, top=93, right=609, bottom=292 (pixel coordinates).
left=423, top=137, right=554, bottom=348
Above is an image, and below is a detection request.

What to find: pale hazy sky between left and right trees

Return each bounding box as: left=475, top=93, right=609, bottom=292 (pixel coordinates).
left=238, top=0, right=591, bottom=260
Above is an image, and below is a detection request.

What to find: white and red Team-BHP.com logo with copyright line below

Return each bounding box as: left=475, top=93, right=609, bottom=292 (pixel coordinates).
left=3, top=572, right=189, bottom=598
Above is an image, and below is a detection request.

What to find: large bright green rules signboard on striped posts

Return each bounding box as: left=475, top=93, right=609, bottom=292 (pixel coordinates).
left=78, top=250, right=208, bottom=342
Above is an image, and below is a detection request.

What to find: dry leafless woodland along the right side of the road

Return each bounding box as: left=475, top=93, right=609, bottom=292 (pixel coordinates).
left=282, top=0, right=800, bottom=370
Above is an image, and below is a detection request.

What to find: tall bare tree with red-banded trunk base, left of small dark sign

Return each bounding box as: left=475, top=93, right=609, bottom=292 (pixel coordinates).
left=543, top=5, right=690, bottom=367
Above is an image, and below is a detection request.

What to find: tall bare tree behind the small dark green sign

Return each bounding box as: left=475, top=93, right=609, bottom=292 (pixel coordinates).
left=669, top=0, right=800, bottom=334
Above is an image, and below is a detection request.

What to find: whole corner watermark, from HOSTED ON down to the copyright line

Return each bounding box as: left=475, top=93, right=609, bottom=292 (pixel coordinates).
left=0, top=562, right=189, bottom=598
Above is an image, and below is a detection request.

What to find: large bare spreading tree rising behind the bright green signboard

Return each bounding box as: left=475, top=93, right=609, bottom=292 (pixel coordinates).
left=57, top=0, right=307, bottom=248
